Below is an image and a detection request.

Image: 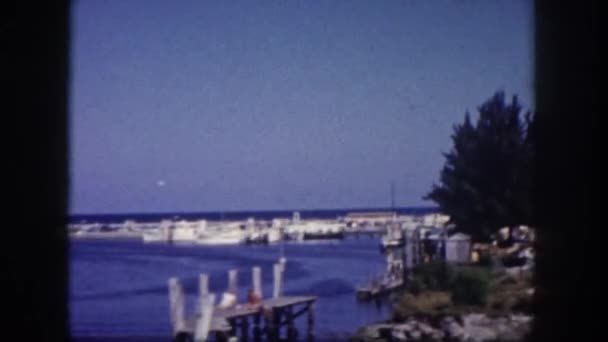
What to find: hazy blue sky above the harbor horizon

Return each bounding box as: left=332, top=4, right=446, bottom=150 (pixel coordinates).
left=70, top=0, right=534, bottom=214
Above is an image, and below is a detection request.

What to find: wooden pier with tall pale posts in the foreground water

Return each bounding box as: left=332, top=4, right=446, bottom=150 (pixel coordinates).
left=169, top=261, right=317, bottom=342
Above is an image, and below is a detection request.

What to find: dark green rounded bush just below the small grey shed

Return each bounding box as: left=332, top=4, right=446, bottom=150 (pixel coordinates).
left=451, top=269, right=490, bottom=305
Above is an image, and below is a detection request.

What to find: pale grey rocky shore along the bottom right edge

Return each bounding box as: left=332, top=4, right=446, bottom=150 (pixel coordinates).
left=351, top=314, right=532, bottom=342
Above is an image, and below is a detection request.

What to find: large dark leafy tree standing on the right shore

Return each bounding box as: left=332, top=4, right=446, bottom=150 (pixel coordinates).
left=424, top=92, right=534, bottom=241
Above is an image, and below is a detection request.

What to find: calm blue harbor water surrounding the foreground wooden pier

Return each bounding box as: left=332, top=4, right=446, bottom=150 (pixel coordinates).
left=70, top=238, right=390, bottom=341
